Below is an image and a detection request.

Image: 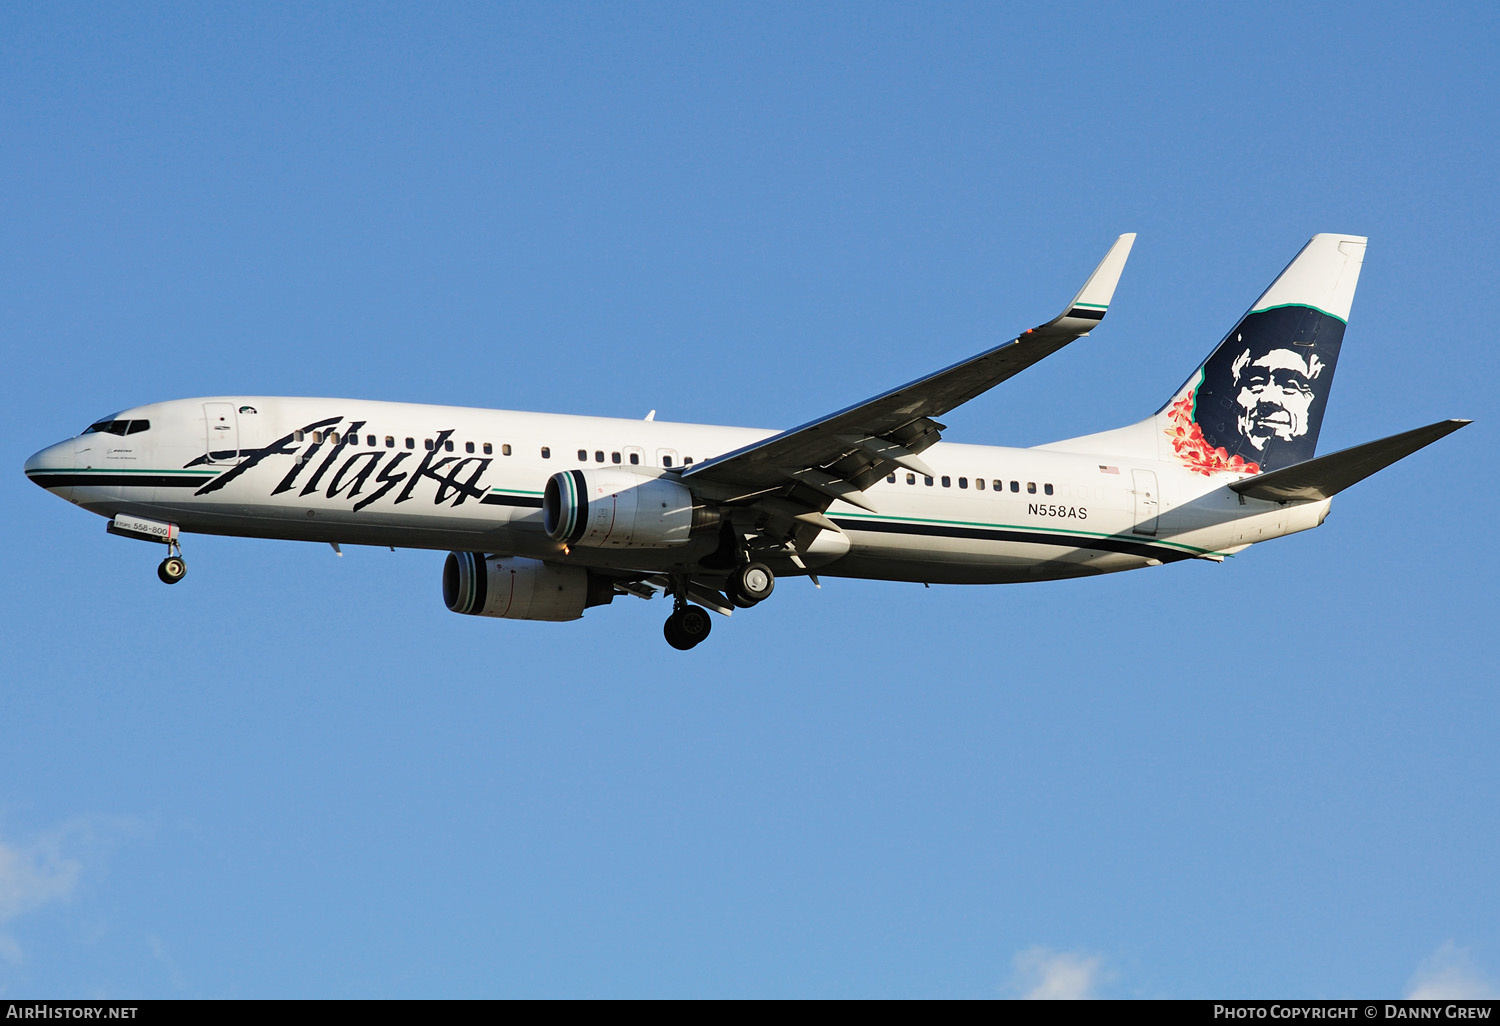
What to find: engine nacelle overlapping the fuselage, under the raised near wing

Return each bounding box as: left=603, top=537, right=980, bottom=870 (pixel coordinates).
left=542, top=468, right=693, bottom=549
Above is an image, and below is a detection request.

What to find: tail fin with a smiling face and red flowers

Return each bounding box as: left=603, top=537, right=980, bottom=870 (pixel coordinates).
left=1154, top=236, right=1365, bottom=474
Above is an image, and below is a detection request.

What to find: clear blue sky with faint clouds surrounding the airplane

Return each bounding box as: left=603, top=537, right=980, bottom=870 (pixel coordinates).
left=0, top=3, right=1500, bottom=998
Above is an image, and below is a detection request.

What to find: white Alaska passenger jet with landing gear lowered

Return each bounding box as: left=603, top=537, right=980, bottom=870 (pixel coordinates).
left=26, top=234, right=1470, bottom=650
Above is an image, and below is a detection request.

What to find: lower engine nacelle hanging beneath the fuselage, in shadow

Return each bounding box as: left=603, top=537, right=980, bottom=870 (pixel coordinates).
left=443, top=552, right=615, bottom=620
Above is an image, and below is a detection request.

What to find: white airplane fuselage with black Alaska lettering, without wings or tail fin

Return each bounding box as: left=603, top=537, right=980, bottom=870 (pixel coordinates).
left=27, top=396, right=1329, bottom=584
